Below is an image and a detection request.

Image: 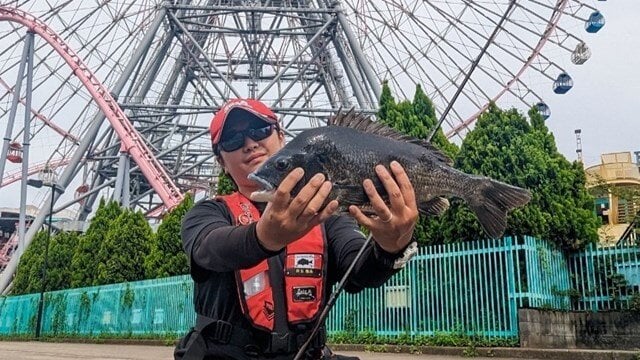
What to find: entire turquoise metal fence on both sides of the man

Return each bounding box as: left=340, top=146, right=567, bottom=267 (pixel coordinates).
left=0, top=237, right=640, bottom=338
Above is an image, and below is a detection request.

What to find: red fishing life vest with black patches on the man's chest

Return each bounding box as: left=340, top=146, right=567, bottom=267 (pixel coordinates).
left=218, top=192, right=327, bottom=332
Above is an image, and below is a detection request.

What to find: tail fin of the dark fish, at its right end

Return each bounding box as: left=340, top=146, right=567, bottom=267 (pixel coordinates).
left=466, top=177, right=531, bottom=239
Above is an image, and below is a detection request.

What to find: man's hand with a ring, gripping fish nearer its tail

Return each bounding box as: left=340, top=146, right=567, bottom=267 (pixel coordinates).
left=349, top=161, right=418, bottom=253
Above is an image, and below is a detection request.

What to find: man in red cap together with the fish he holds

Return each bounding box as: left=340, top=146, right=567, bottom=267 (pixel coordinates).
left=176, top=99, right=531, bottom=359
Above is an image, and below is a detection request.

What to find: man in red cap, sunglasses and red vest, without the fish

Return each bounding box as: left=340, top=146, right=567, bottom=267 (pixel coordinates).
left=175, top=99, right=418, bottom=360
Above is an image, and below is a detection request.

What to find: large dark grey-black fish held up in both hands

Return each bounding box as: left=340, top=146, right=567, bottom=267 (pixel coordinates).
left=249, top=111, right=531, bottom=238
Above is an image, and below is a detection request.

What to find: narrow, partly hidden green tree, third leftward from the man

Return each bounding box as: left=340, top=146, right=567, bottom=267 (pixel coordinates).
left=71, top=199, right=122, bottom=288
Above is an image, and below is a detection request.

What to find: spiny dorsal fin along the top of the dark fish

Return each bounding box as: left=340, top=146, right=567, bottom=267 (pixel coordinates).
left=327, top=108, right=453, bottom=165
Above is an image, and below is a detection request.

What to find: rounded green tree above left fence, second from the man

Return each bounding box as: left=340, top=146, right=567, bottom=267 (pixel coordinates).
left=94, top=210, right=153, bottom=285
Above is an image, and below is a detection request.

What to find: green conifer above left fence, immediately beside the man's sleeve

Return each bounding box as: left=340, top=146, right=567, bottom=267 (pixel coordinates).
left=144, top=193, right=193, bottom=279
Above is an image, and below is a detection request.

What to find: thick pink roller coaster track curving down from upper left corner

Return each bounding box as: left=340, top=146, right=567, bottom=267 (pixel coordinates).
left=0, top=6, right=183, bottom=209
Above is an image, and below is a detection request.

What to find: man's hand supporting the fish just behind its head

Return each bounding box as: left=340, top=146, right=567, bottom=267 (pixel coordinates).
left=256, top=168, right=338, bottom=251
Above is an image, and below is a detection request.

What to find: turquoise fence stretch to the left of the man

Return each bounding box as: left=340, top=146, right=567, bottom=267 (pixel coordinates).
left=0, top=276, right=195, bottom=337
